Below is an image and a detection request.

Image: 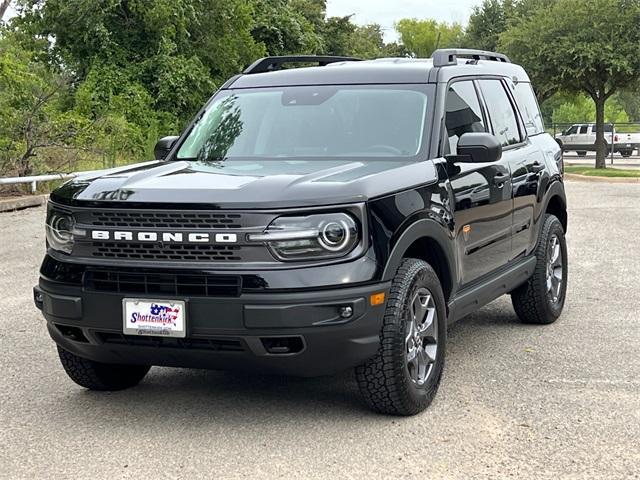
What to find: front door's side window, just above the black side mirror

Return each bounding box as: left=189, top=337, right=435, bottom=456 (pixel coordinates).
left=445, top=81, right=486, bottom=154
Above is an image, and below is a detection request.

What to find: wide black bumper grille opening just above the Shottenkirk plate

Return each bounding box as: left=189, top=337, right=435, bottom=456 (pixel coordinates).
left=84, top=270, right=242, bottom=297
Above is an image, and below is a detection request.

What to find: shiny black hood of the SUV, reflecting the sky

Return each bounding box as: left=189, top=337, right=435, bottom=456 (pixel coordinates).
left=51, top=159, right=437, bottom=208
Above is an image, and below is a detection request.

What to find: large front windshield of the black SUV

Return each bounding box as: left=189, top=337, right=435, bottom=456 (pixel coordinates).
left=177, top=86, right=427, bottom=161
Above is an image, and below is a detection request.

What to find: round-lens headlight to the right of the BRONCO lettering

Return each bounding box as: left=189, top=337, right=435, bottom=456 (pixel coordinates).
left=249, top=213, right=359, bottom=260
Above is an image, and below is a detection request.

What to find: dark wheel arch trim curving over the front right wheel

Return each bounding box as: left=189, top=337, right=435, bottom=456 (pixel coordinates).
left=382, top=219, right=457, bottom=302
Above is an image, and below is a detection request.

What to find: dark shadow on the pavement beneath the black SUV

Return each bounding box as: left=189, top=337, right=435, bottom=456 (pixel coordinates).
left=45, top=305, right=522, bottom=427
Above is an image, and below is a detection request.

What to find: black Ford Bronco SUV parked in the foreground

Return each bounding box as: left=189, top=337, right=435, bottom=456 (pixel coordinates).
left=34, top=50, right=567, bottom=415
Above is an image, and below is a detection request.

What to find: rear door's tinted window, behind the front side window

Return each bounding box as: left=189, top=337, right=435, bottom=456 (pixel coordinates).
left=479, top=80, right=522, bottom=147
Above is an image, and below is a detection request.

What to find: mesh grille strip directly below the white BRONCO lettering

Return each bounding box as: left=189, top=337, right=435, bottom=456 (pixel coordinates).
left=91, top=242, right=242, bottom=262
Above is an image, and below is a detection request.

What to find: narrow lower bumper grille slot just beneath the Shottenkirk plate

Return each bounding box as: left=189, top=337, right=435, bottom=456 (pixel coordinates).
left=96, top=332, right=245, bottom=352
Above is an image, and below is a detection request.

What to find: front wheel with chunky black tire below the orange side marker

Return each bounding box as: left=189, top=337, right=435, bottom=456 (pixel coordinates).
left=356, top=258, right=447, bottom=415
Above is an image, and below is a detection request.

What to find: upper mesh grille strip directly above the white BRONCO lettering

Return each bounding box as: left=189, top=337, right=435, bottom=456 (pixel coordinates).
left=90, top=210, right=243, bottom=229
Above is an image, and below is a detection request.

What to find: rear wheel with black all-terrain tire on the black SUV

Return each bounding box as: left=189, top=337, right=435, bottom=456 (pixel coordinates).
left=511, top=215, right=568, bottom=325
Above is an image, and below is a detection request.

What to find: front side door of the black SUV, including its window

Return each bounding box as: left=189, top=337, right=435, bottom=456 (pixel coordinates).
left=443, top=80, right=513, bottom=286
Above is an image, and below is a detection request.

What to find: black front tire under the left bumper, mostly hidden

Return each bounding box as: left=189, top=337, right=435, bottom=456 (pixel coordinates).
left=58, top=347, right=151, bottom=391
